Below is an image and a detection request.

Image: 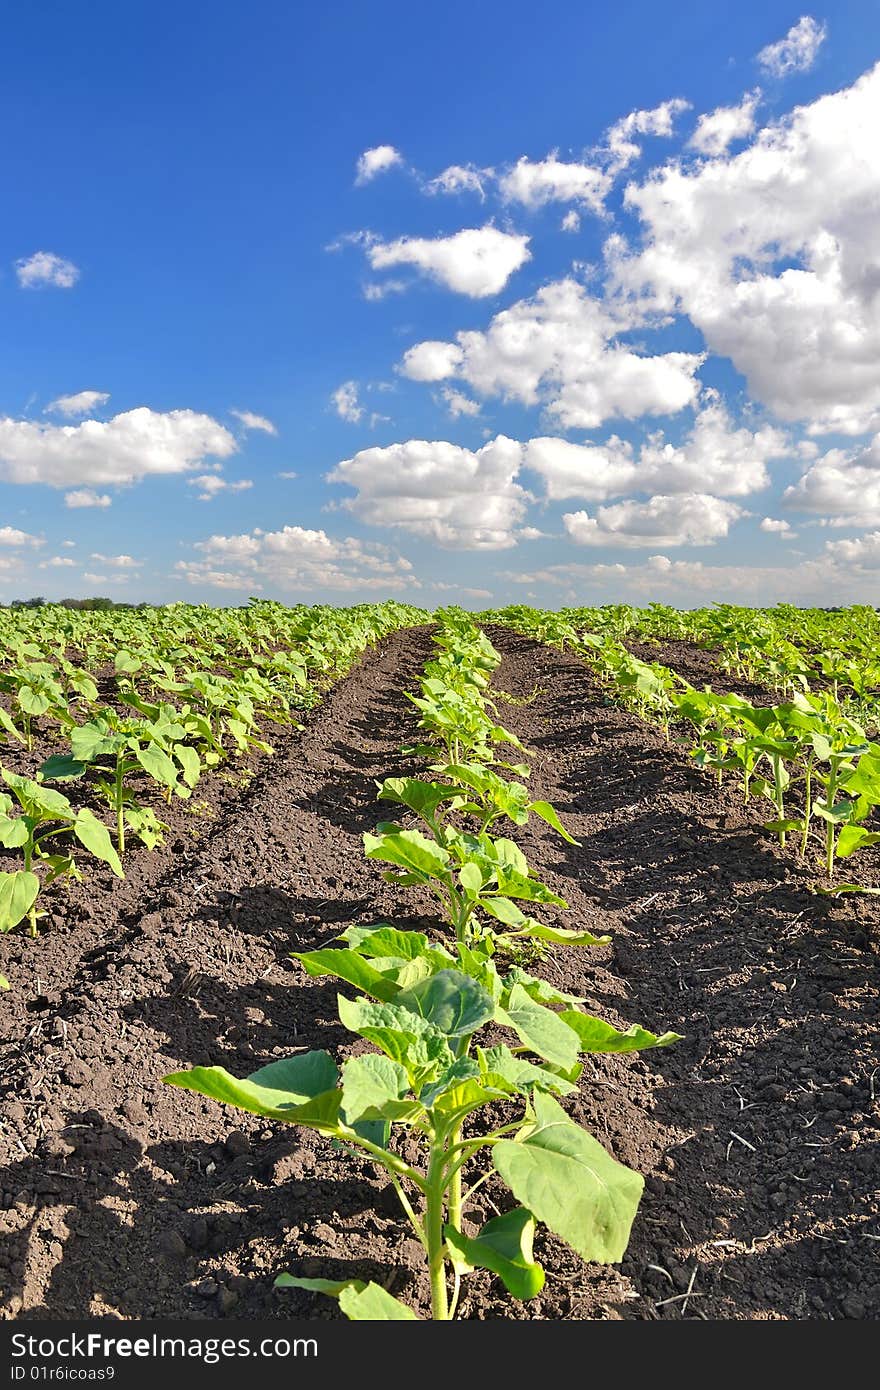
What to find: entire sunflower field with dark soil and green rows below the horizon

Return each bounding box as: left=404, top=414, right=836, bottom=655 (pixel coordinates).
left=0, top=603, right=880, bottom=1319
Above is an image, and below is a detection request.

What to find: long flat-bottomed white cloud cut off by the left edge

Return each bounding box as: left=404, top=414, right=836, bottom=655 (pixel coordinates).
left=0, top=406, right=236, bottom=492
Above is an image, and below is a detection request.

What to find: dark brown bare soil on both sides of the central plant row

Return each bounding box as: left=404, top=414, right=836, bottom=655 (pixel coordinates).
left=0, top=628, right=880, bottom=1319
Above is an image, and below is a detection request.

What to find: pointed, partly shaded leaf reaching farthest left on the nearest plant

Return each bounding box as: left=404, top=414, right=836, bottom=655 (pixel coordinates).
left=163, top=1052, right=342, bottom=1127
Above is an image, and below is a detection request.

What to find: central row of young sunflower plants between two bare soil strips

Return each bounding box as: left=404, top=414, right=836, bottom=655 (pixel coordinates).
left=164, top=610, right=677, bottom=1321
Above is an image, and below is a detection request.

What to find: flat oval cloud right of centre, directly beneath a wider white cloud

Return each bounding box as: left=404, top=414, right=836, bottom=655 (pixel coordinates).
left=562, top=492, right=748, bottom=548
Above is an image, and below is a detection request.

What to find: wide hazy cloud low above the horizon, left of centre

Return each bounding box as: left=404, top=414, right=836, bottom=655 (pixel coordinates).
left=175, top=525, right=418, bottom=594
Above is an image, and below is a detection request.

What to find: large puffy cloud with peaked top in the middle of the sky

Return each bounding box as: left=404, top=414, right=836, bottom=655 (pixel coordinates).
left=402, top=279, right=702, bottom=430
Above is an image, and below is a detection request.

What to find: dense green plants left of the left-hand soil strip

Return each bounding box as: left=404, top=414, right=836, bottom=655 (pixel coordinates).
left=0, top=602, right=427, bottom=935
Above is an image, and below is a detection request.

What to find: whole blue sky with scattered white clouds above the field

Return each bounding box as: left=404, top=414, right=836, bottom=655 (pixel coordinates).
left=0, top=0, right=880, bottom=607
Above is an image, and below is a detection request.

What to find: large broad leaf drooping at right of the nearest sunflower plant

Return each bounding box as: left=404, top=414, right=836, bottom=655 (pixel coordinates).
left=492, top=1091, right=645, bottom=1264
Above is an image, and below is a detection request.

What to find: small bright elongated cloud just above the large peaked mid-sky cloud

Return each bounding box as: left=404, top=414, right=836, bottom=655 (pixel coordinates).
left=367, top=224, right=531, bottom=299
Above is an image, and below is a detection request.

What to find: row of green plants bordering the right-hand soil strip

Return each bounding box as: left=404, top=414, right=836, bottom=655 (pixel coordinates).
left=486, top=607, right=880, bottom=894
